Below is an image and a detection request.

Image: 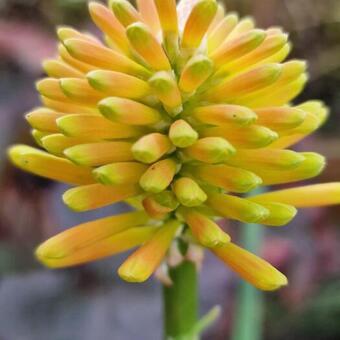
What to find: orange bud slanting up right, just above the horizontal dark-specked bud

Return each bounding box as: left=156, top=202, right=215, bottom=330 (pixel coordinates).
left=205, top=64, right=282, bottom=103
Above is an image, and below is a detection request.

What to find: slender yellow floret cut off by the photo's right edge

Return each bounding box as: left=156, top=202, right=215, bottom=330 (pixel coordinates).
left=249, top=182, right=340, bottom=208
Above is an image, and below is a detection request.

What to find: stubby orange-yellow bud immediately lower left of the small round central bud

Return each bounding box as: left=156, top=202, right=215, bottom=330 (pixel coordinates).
left=132, top=132, right=172, bottom=163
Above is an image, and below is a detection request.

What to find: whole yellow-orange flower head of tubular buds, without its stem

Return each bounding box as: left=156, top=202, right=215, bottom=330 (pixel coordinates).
left=9, top=0, right=340, bottom=290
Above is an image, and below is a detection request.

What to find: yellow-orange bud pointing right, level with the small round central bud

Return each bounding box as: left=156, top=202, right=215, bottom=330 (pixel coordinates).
left=201, top=125, right=279, bottom=149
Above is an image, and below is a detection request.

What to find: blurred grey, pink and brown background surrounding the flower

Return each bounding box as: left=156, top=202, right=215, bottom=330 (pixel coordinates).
left=0, top=0, right=340, bottom=340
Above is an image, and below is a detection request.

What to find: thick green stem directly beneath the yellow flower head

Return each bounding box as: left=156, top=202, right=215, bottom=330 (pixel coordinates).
left=163, top=261, right=198, bottom=339
